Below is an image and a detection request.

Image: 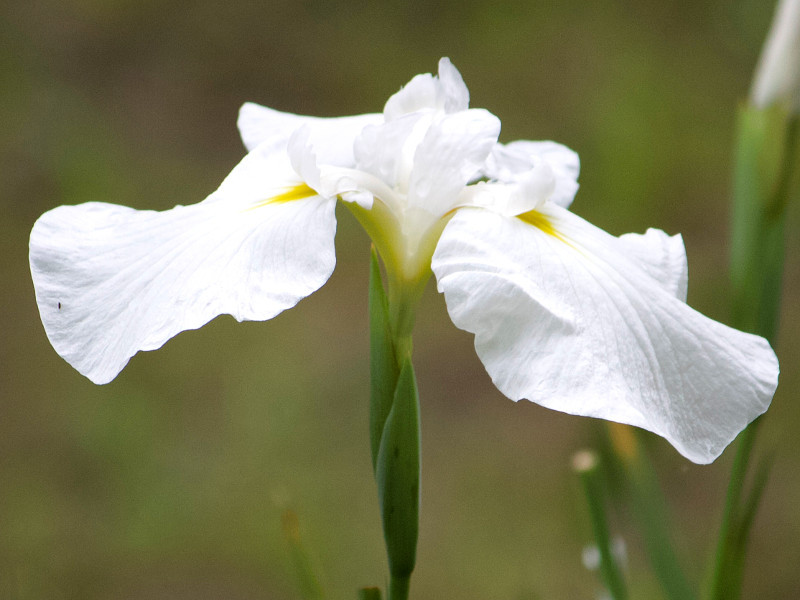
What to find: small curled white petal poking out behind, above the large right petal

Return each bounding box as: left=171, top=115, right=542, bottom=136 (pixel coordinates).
left=482, top=140, right=580, bottom=208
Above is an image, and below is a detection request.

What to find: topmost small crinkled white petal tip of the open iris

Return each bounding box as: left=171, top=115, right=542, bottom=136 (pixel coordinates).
left=383, top=58, right=469, bottom=121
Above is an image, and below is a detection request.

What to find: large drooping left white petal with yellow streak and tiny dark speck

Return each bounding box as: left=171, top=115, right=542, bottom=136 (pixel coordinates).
left=30, top=154, right=336, bottom=383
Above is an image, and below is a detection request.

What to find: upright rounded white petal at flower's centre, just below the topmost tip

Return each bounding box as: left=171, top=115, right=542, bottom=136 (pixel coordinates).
left=408, top=109, right=500, bottom=215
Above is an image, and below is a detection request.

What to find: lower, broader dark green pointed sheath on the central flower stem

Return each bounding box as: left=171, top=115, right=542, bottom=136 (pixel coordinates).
left=375, top=358, right=420, bottom=580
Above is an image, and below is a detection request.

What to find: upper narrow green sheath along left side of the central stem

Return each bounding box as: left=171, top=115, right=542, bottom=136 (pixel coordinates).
left=369, top=247, right=400, bottom=471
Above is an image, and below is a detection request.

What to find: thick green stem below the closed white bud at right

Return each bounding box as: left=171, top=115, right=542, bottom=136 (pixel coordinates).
left=709, top=106, right=800, bottom=600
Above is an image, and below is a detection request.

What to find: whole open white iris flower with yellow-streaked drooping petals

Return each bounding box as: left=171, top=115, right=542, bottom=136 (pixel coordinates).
left=30, top=59, right=778, bottom=463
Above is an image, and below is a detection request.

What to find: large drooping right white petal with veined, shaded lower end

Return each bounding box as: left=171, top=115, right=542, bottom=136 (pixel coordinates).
left=432, top=204, right=778, bottom=463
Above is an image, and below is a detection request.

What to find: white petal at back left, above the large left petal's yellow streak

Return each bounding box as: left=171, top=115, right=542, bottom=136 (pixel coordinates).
left=237, top=102, right=383, bottom=168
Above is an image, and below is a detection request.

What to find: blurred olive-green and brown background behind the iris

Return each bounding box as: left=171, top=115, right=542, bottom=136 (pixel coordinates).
left=0, top=0, right=800, bottom=600
